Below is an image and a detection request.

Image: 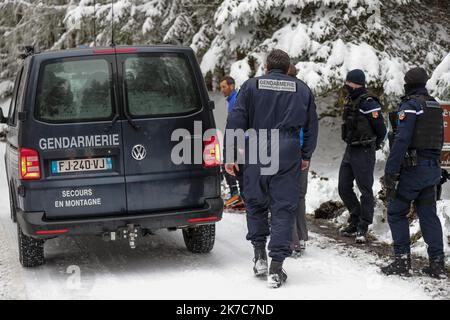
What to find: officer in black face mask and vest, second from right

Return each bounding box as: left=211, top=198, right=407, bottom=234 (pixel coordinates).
left=338, top=69, right=386, bottom=243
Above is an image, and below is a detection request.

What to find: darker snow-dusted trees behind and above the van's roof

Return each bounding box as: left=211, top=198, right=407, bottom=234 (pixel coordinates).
left=0, top=0, right=219, bottom=95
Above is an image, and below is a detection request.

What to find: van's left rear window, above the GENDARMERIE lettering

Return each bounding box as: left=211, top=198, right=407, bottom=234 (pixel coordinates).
left=37, top=59, right=113, bottom=122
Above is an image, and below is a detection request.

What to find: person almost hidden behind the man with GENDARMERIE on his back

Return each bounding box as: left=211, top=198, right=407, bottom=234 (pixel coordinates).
left=288, top=63, right=309, bottom=258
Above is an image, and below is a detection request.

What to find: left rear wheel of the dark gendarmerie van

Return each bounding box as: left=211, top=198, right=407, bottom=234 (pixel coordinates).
left=17, top=224, right=45, bottom=268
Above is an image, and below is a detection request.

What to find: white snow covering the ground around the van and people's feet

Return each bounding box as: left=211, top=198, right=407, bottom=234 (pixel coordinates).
left=0, top=96, right=448, bottom=299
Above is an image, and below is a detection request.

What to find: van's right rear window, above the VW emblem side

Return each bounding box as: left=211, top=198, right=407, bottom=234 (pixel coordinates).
left=124, top=54, right=201, bottom=117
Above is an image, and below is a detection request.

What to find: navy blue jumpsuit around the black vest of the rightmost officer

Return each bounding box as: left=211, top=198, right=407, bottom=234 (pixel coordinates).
left=385, top=88, right=444, bottom=258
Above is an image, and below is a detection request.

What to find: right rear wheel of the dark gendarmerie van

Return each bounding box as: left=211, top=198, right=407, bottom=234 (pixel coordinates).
left=183, top=224, right=216, bottom=253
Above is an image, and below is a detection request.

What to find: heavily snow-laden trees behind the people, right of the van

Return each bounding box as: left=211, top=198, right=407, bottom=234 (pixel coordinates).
left=202, top=0, right=450, bottom=102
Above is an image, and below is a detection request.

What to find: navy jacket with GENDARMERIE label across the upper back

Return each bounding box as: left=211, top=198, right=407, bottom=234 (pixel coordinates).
left=225, top=69, right=318, bottom=160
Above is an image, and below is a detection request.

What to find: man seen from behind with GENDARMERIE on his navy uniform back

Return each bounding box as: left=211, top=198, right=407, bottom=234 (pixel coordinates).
left=225, top=49, right=318, bottom=288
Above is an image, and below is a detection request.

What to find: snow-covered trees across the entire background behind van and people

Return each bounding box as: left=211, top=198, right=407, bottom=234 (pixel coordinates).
left=0, top=0, right=450, bottom=101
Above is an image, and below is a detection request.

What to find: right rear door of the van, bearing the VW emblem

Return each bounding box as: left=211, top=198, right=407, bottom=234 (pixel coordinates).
left=117, top=48, right=219, bottom=213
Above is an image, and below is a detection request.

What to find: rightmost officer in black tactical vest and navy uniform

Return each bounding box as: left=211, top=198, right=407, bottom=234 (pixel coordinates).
left=381, top=68, right=446, bottom=278
